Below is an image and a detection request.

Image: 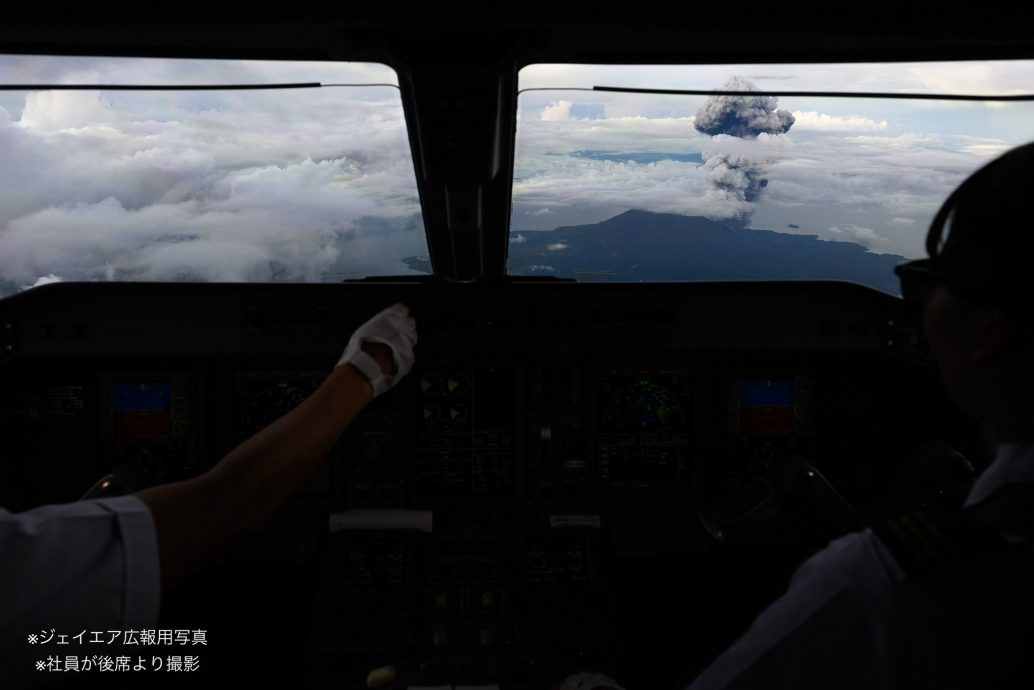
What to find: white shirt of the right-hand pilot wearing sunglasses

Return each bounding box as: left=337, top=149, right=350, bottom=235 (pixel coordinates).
left=690, top=444, right=1034, bottom=690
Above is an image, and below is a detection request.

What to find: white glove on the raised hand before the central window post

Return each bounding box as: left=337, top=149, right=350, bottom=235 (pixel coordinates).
left=337, top=304, right=417, bottom=397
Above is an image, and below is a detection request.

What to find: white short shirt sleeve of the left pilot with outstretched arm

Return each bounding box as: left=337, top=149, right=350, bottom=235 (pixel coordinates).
left=0, top=496, right=161, bottom=678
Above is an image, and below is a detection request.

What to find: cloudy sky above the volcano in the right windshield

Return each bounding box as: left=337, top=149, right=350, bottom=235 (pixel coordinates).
left=511, top=61, right=1034, bottom=258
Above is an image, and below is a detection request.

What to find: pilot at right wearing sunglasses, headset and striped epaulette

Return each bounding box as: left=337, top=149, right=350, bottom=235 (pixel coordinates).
left=691, top=144, right=1034, bottom=690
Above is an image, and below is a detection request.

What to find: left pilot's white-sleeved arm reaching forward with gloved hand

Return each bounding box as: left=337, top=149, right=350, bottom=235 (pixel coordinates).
left=0, top=304, right=417, bottom=678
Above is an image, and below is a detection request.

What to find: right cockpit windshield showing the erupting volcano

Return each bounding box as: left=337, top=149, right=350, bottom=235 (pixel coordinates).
left=508, top=60, right=1034, bottom=294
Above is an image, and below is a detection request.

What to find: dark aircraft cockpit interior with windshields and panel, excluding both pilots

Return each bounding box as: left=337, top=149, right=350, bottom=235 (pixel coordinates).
left=0, top=13, right=1034, bottom=690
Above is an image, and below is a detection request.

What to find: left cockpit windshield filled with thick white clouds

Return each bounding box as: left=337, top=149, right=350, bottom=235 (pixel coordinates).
left=0, top=55, right=427, bottom=297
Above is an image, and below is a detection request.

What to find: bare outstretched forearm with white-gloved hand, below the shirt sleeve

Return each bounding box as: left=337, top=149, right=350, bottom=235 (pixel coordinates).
left=136, top=304, right=417, bottom=590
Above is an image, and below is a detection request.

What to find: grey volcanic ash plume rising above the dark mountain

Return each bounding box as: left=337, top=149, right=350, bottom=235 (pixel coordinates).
left=694, top=77, right=794, bottom=228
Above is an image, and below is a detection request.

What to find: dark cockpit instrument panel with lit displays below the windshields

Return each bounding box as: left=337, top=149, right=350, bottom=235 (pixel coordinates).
left=0, top=283, right=979, bottom=688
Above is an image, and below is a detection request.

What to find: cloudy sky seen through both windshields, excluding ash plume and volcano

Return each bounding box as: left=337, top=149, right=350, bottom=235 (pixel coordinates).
left=0, top=56, right=1034, bottom=295
